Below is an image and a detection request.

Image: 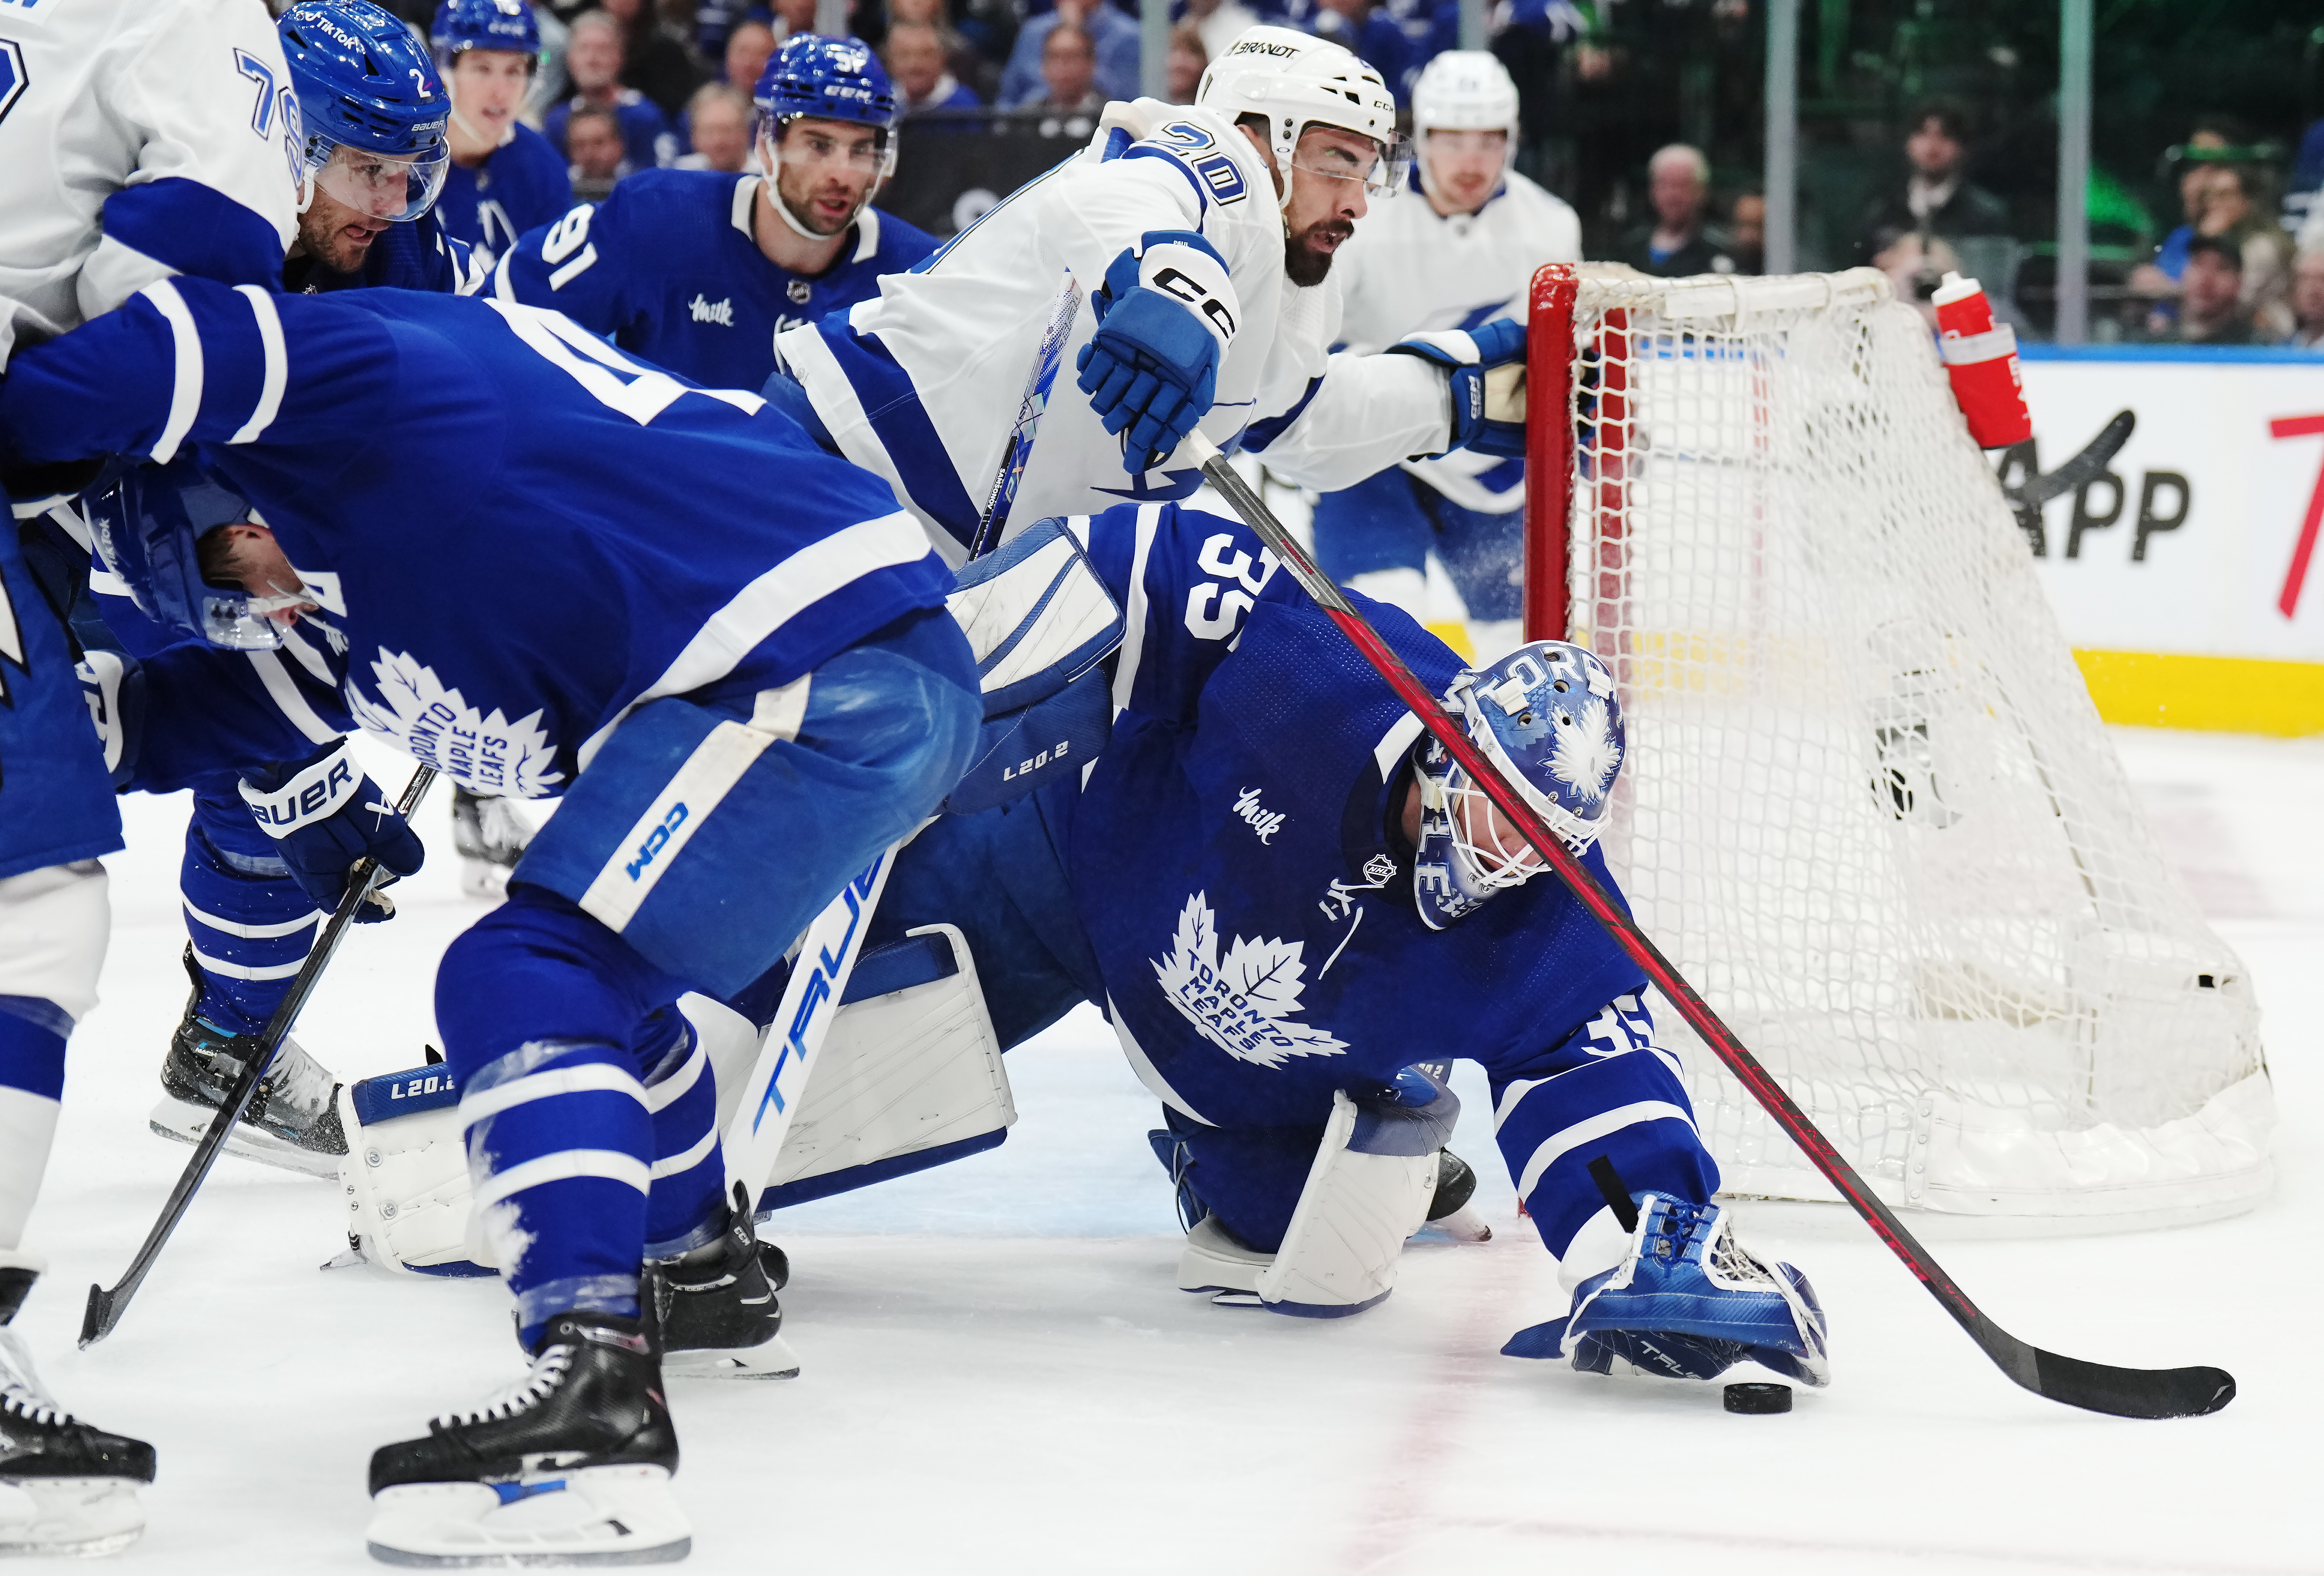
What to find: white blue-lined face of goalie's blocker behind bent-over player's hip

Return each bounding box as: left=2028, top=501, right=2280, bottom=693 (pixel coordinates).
left=944, top=521, right=1125, bottom=716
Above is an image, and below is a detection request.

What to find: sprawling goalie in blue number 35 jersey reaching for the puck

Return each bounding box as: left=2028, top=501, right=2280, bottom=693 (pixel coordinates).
left=802, top=504, right=1827, bottom=1383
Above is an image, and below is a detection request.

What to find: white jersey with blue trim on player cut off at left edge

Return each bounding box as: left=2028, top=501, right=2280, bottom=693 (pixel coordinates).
left=0, top=0, right=302, bottom=367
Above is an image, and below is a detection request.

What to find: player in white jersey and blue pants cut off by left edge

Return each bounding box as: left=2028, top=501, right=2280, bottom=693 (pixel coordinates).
left=0, top=0, right=300, bottom=1555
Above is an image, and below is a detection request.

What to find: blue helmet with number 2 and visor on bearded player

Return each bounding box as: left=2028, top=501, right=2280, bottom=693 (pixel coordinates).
left=274, top=0, right=451, bottom=221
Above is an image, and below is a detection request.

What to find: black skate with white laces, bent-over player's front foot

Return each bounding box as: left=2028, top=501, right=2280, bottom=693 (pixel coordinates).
left=365, top=1313, right=692, bottom=1567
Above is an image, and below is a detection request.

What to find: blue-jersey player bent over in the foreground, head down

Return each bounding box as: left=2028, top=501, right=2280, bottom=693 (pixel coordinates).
left=0, top=281, right=978, bottom=1564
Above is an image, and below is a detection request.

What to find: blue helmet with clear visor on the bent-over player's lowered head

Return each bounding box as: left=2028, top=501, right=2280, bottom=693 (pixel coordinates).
left=88, top=456, right=314, bottom=651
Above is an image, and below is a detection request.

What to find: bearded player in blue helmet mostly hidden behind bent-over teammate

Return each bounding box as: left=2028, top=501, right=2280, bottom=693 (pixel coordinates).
left=109, top=0, right=490, bottom=1176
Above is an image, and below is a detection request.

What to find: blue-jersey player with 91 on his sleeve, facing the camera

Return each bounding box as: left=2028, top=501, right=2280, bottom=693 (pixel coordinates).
left=493, top=33, right=936, bottom=391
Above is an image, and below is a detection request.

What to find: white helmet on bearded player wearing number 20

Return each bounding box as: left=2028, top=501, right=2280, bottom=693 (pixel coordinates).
left=1195, top=28, right=1411, bottom=202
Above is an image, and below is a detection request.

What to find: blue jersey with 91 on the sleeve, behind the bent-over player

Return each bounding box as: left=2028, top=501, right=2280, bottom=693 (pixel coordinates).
left=493, top=170, right=936, bottom=391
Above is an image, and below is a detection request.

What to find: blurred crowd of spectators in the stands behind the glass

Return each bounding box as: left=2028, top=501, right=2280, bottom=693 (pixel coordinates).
left=353, top=0, right=2324, bottom=349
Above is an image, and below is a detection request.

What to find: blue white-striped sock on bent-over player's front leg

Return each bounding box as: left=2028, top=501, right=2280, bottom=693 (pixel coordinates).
left=437, top=881, right=723, bottom=1348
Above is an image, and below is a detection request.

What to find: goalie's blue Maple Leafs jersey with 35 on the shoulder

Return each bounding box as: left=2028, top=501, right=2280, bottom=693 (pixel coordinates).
left=1059, top=504, right=1652, bottom=1127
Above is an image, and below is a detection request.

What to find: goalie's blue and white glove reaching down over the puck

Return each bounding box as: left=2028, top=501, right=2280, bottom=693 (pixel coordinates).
left=1501, top=1193, right=1831, bottom=1385
